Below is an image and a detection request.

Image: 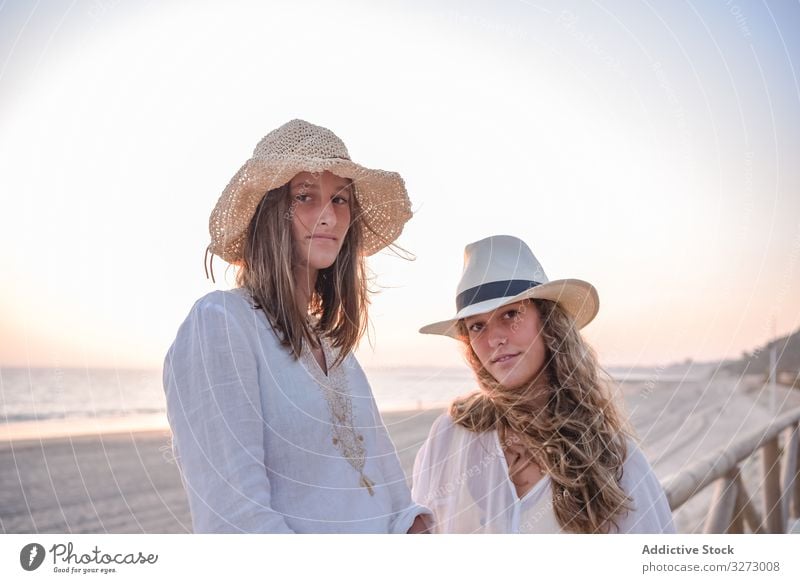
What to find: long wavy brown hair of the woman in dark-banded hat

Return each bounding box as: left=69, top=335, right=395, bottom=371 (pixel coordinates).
left=450, top=299, right=631, bottom=533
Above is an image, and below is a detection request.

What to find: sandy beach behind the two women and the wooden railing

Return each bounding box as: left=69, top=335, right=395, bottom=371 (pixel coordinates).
left=0, top=377, right=800, bottom=533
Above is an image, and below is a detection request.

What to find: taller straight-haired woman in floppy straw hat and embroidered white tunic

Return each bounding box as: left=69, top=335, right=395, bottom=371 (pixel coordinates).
left=164, top=120, right=428, bottom=533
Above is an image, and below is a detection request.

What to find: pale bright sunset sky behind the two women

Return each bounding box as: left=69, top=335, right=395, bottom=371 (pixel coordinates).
left=0, top=0, right=800, bottom=368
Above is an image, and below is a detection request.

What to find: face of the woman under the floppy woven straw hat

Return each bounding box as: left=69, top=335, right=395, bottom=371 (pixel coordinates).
left=289, top=170, right=352, bottom=270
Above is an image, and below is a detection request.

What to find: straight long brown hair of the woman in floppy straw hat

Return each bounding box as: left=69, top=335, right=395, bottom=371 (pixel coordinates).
left=236, top=183, right=369, bottom=366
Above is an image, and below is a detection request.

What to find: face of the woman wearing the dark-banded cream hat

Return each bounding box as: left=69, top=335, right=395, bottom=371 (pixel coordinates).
left=464, top=300, right=547, bottom=389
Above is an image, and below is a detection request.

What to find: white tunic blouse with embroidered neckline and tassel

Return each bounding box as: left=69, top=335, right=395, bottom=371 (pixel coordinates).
left=164, top=288, right=429, bottom=533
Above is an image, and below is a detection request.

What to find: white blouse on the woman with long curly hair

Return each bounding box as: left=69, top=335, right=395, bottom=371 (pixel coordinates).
left=412, top=413, right=675, bottom=533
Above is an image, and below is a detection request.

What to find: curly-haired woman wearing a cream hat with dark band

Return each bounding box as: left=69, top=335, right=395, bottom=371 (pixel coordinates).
left=412, top=236, right=675, bottom=533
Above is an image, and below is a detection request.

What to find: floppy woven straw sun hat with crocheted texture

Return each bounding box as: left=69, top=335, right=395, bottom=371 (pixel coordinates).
left=208, top=119, right=412, bottom=263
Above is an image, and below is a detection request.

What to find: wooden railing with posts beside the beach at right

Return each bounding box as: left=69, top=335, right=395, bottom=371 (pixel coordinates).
left=664, top=408, right=800, bottom=533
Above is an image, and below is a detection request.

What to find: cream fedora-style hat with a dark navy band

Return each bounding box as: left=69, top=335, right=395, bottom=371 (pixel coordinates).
left=420, top=235, right=600, bottom=338
